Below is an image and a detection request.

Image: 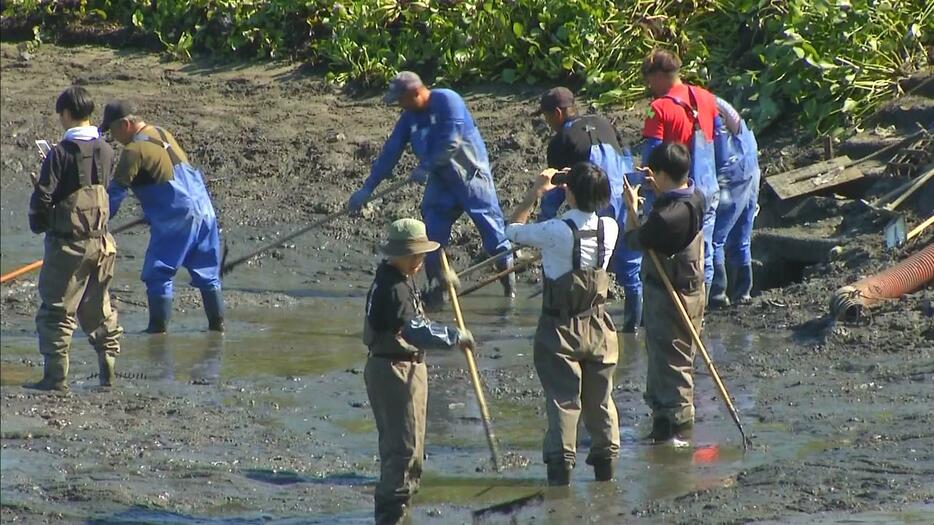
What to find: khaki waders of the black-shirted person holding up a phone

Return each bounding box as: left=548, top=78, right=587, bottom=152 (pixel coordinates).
left=642, top=196, right=706, bottom=441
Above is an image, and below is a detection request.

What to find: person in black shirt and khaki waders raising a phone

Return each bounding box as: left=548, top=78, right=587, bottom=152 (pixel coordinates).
left=624, top=142, right=706, bottom=443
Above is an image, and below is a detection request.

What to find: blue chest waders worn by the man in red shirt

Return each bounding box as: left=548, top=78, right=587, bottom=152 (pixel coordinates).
left=665, top=86, right=720, bottom=287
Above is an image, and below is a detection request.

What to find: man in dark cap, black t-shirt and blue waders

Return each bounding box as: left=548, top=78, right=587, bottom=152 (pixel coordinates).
left=534, top=87, right=642, bottom=333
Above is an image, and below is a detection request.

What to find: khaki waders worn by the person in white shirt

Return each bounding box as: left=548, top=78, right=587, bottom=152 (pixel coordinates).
left=533, top=219, right=619, bottom=485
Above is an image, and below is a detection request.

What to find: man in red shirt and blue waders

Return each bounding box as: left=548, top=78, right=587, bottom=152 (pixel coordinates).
left=642, top=49, right=721, bottom=290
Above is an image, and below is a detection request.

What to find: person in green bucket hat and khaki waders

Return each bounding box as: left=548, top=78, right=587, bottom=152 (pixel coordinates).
left=363, top=219, right=473, bottom=525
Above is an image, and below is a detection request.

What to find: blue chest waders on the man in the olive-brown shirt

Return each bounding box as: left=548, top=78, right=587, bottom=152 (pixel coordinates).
left=132, top=128, right=224, bottom=333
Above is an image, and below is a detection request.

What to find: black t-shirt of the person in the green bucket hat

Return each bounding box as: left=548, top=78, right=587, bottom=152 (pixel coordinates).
left=366, top=261, right=420, bottom=333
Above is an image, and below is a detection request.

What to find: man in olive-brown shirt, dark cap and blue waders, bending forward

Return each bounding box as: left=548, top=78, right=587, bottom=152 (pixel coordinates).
left=100, top=100, right=224, bottom=333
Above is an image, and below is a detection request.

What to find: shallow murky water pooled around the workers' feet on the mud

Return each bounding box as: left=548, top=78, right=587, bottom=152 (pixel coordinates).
left=2, top=287, right=840, bottom=523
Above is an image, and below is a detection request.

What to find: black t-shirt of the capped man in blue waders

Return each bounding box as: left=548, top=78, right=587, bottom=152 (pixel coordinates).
left=548, top=115, right=622, bottom=169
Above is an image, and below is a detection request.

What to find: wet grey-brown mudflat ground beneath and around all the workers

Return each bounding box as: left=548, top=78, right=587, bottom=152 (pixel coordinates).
left=0, top=44, right=934, bottom=524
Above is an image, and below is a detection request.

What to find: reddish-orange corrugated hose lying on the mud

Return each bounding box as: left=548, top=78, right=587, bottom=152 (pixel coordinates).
left=830, top=244, right=934, bottom=321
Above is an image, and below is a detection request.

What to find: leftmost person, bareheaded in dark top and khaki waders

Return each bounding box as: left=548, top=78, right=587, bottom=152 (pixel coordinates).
left=25, top=87, right=123, bottom=390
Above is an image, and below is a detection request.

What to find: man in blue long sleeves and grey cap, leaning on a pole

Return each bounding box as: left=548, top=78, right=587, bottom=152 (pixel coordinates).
left=349, top=71, right=516, bottom=309
